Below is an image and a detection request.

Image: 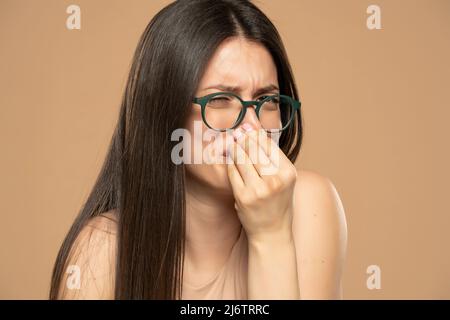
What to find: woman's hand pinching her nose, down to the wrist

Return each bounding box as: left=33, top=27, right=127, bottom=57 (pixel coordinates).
left=227, top=123, right=297, bottom=241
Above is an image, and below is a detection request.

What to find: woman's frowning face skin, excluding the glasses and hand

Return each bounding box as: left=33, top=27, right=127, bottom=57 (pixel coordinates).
left=186, top=38, right=279, bottom=193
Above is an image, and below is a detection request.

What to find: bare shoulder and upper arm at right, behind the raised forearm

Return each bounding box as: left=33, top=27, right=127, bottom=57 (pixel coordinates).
left=292, top=170, right=347, bottom=299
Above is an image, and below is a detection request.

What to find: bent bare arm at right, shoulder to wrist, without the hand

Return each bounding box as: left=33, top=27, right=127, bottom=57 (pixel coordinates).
left=243, top=171, right=347, bottom=299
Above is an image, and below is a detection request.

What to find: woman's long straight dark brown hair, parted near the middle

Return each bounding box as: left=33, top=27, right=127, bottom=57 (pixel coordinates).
left=50, top=0, right=302, bottom=299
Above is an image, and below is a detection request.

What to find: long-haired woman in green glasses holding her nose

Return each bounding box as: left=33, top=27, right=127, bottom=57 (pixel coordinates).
left=50, top=0, right=347, bottom=299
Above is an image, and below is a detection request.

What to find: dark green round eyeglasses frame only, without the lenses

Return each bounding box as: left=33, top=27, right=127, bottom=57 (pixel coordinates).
left=192, top=92, right=302, bottom=132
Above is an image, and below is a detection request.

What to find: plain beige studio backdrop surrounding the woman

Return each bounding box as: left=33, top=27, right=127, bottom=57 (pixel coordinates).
left=0, top=0, right=450, bottom=299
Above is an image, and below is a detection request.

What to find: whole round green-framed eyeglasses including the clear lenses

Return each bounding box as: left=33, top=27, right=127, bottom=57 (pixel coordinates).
left=193, top=92, right=301, bottom=132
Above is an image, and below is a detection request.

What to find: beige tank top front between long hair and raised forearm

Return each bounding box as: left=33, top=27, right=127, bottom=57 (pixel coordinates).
left=182, top=228, right=248, bottom=300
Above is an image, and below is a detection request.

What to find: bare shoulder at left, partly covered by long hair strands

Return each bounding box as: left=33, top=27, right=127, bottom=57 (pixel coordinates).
left=59, top=211, right=118, bottom=299
